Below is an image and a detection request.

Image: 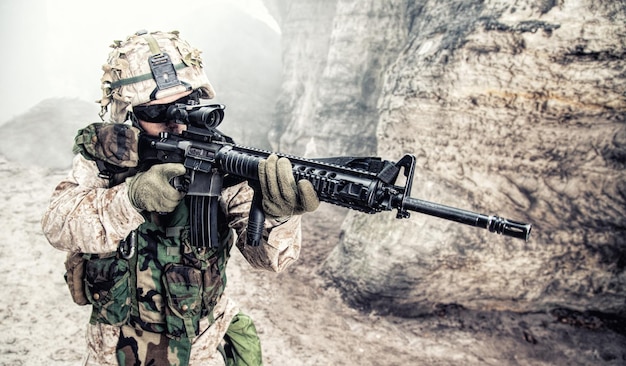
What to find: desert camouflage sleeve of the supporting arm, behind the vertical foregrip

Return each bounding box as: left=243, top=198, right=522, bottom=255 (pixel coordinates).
left=221, top=183, right=302, bottom=272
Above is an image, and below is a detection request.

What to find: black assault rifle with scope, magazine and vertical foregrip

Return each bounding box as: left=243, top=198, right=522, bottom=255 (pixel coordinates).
left=139, top=104, right=531, bottom=247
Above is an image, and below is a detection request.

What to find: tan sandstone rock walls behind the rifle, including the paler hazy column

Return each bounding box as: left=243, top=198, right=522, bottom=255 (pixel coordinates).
left=270, top=0, right=626, bottom=316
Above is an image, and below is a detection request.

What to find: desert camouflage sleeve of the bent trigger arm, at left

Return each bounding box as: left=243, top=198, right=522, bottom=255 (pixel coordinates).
left=41, top=154, right=144, bottom=253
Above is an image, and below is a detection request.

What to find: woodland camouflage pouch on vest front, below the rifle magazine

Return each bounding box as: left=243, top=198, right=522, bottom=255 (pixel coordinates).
left=163, top=263, right=203, bottom=339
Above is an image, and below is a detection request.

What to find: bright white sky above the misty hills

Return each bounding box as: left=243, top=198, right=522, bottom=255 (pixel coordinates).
left=0, top=0, right=280, bottom=124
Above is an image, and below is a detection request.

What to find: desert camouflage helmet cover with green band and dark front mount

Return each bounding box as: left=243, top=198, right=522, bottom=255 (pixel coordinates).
left=99, top=31, right=215, bottom=123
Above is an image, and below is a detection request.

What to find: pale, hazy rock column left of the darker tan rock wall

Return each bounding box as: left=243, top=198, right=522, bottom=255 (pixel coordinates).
left=266, top=0, right=404, bottom=157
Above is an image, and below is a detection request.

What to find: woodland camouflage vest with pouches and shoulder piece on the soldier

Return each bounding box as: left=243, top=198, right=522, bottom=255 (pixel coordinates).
left=74, top=124, right=234, bottom=339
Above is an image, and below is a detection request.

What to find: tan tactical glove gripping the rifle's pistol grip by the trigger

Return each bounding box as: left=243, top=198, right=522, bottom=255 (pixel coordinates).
left=126, top=163, right=185, bottom=212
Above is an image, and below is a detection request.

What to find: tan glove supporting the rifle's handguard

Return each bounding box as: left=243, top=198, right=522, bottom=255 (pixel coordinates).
left=259, top=154, right=320, bottom=221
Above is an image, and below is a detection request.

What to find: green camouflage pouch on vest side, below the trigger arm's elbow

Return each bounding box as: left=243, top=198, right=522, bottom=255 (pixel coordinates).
left=85, top=256, right=131, bottom=325
